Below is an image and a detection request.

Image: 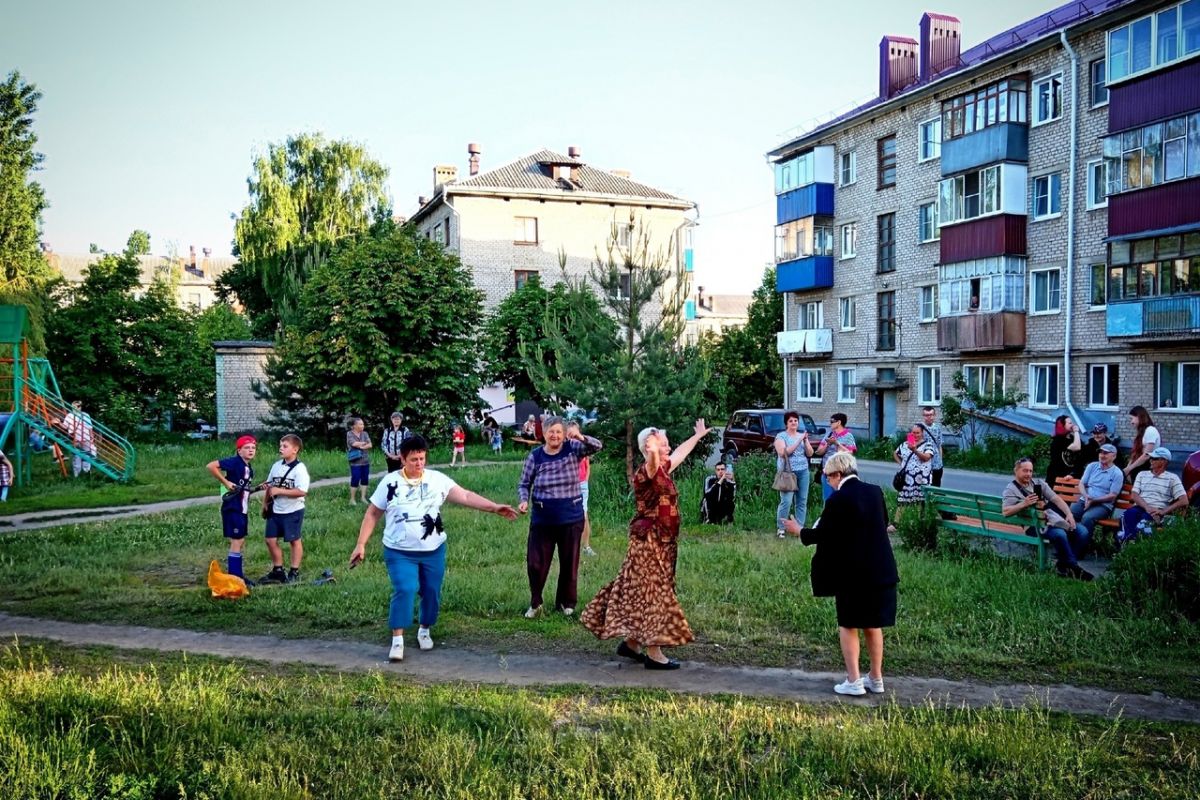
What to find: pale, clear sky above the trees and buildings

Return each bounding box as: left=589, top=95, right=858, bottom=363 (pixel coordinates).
left=7, top=0, right=1054, bottom=294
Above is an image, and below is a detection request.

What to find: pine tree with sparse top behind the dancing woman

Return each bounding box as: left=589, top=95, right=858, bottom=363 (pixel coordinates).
left=526, top=219, right=708, bottom=480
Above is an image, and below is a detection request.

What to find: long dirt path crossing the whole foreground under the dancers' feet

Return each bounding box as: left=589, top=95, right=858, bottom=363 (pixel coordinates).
left=0, top=613, right=1200, bottom=723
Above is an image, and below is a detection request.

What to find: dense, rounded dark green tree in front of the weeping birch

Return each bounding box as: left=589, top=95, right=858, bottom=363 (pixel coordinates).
left=262, top=219, right=482, bottom=438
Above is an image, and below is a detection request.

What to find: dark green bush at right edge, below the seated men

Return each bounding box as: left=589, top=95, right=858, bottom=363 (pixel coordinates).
left=1105, top=518, right=1200, bottom=622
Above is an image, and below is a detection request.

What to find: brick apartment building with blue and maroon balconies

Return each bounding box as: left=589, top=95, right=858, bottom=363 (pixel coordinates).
left=768, top=0, right=1200, bottom=450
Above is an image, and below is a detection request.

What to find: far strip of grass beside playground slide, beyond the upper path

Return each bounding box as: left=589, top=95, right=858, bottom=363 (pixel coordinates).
left=0, top=434, right=527, bottom=515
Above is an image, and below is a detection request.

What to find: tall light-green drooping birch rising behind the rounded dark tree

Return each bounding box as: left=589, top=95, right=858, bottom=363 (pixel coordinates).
left=220, top=133, right=390, bottom=338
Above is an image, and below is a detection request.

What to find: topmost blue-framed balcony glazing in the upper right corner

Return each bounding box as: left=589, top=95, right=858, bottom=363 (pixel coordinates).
left=1108, top=0, right=1200, bottom=83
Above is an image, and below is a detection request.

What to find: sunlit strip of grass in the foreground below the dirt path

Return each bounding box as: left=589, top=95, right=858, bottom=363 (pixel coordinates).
left=0, top=643, right=1200, bottom=800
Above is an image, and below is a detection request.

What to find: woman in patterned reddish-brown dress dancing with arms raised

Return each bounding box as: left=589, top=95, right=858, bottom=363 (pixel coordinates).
left=580, top=420, right=709, bottom=669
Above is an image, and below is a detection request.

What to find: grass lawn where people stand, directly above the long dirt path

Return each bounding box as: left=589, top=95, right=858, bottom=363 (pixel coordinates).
left=0, top=455, right=1200, bottom=698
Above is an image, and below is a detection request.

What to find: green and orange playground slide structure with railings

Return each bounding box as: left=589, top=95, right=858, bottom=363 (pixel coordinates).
left=0, top=306, right=137, bottom=486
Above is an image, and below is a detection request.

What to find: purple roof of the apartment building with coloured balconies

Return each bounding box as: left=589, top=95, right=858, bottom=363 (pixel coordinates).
left=767, top=0, right=1145, bottom=158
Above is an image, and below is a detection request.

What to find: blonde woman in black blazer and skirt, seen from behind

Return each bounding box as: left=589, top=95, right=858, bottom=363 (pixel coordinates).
left=786, top=453, right=900, bottom=696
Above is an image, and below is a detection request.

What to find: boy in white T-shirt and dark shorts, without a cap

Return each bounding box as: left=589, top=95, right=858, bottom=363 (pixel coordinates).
left=258, top=433, right=308, bottom=583
